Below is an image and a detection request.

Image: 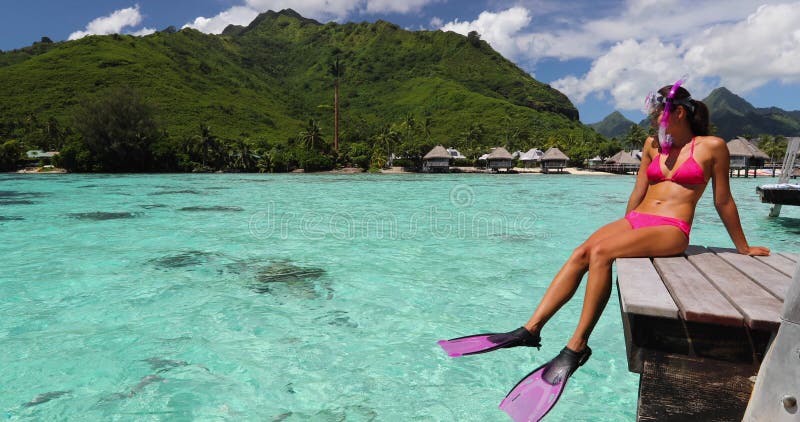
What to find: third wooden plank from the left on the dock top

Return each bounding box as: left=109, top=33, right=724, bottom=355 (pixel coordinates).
left=686, top=248, right=782, bottom=331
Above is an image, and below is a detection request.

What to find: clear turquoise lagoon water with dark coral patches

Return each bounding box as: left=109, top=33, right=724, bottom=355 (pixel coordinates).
left=0, top=174, right=800, bottom=421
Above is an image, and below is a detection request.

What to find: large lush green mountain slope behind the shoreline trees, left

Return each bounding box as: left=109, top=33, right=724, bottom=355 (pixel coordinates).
left=0, top=10, right=591, bottom=152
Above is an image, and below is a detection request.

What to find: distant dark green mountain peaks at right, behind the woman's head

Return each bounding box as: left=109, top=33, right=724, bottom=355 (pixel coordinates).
left=703, top=87, right=800, bottom=140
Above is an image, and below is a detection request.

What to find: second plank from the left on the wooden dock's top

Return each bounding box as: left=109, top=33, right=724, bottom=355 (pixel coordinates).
left=653, top=257, right=744, bottom=326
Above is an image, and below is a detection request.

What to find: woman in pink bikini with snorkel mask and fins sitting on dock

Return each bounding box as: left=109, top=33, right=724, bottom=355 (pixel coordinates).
left=439, top=81, right=769, bottom=420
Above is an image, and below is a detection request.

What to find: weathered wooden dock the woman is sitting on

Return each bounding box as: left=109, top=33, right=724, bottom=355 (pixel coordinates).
left=617, top=245, right=800, bottom=421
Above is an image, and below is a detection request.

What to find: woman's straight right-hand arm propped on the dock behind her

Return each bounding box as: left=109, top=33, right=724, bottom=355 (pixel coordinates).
left=705, top=137, right=769, bottom=255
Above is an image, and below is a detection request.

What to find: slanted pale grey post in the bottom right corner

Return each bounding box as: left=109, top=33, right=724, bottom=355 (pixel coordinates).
left=743, top=265, right=800, bottom=422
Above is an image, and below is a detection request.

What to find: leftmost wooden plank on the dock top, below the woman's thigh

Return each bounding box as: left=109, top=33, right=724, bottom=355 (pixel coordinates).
left=617, top=258, right=678, bottom=319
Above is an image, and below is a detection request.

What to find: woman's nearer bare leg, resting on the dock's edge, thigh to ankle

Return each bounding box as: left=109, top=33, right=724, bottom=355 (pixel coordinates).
left=567, top=226, right=689, bottom=351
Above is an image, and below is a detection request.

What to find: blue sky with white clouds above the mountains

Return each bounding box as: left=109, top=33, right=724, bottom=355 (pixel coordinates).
left=0, top=0, right=800, bottom=123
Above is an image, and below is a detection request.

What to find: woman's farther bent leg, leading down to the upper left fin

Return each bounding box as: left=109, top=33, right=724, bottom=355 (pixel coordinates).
left=525, top=218, right=633, bottom=332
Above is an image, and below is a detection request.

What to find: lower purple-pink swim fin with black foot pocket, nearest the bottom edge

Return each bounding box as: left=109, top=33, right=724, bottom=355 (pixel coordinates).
left=500, top=347, right=592, bottom=422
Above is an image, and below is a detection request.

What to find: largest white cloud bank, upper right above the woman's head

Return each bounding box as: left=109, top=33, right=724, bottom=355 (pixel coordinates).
left=552, top=3, right=800, bottom=110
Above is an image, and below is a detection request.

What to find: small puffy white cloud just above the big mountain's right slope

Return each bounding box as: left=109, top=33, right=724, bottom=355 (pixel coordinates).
left=441, top=7, right=531, bottom=58
